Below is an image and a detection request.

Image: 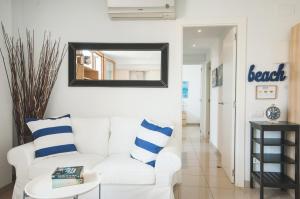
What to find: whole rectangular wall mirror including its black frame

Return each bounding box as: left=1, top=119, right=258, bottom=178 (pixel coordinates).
left=69, top=43, right=168, bottom=87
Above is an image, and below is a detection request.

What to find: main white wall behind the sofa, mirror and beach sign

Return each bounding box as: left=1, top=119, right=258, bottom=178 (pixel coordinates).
left=8, top=0, right=300, bottom=183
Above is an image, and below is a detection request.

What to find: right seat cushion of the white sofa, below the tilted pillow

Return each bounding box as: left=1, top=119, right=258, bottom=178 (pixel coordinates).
left=94, top=154, right=155, bottom=185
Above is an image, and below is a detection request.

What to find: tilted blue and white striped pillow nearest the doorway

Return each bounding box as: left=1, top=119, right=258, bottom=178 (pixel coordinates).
left=130, top=119, right=173, bottom=167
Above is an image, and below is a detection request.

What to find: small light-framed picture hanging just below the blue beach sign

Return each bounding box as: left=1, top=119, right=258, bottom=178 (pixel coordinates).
left=255, top=85, right=278, bottom=100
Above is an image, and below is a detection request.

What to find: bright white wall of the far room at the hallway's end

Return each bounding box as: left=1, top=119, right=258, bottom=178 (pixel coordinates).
left=182, top=65, right=202, bottom=124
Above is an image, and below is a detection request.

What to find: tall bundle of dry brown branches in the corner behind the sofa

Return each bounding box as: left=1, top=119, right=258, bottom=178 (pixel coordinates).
left=0, top=23, right=67, bottom=144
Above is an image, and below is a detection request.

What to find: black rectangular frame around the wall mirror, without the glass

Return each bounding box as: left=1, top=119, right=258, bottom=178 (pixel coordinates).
left=68, top=42, right=169, bottom=88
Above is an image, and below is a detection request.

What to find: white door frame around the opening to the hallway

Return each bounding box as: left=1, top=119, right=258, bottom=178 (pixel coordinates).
left=178, top=18, right=247, bottom=187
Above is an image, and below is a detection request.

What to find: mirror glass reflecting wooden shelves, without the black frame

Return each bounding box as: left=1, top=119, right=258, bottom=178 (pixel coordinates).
left=76, top=50, right=161, bottom=80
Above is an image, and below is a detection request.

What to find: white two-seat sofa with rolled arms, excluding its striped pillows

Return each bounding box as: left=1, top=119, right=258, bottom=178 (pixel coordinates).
left=7, top=117, right=181, bottom=199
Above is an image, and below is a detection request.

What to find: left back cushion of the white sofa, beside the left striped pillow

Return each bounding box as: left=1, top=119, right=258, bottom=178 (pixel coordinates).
left=72, top=118, right=110, bottom=156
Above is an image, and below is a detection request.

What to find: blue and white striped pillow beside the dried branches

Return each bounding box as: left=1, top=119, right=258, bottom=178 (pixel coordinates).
left=26, top=115, right=77, bottom=158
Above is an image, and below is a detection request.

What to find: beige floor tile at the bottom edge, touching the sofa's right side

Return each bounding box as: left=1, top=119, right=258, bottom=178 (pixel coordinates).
left=179, top=186, right=213, bottom=199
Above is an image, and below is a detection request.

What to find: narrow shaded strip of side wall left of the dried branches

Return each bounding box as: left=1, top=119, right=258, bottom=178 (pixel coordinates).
left=0, top=0, right=13, bottom=188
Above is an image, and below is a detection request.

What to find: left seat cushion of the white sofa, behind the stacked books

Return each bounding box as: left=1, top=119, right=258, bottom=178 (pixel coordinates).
left=28, top=153, right=105, bottom=179
